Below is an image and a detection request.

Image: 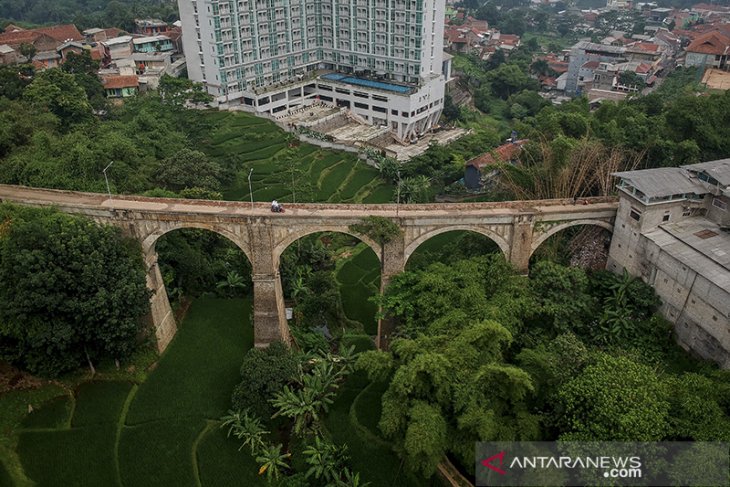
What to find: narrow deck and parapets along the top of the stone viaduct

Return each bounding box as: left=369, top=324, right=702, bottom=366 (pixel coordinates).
left=0, top=185, right=618, bottom=218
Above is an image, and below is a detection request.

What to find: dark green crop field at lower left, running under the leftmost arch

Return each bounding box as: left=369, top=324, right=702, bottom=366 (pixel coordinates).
left=11, top=298, right=258, bottom=486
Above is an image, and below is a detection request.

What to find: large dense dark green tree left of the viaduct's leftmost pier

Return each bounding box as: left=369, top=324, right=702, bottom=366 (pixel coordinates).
left=0, top=204, right=150, bottom=376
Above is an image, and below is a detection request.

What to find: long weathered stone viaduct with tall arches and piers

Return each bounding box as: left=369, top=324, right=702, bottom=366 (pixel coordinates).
left=0, top=185, right=618, bottom=351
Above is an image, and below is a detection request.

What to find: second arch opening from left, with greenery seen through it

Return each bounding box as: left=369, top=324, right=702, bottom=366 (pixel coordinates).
left=275, top=231, right=381, bottom=337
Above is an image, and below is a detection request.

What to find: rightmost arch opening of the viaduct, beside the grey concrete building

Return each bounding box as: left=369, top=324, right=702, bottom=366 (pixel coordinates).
left=530, top=220, right=613, bottom=270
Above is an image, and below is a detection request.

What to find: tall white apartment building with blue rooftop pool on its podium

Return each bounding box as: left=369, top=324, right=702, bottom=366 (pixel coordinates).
left=178, top=0, right=450, bottom=140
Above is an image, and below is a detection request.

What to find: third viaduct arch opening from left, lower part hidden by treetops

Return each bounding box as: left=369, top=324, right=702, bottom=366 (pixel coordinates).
left=405, top=227, right=509, bottom=270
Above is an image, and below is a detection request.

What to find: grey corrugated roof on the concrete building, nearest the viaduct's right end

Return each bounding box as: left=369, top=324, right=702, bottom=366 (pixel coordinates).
left=613, top=167, right=707, bottom=198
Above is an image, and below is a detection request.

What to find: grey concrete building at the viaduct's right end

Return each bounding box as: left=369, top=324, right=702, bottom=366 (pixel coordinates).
left=608, top=159, right=730, bottom=368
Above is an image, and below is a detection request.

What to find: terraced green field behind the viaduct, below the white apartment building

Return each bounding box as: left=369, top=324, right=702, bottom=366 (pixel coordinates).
left=200, top=111, right=393, bottom=203
